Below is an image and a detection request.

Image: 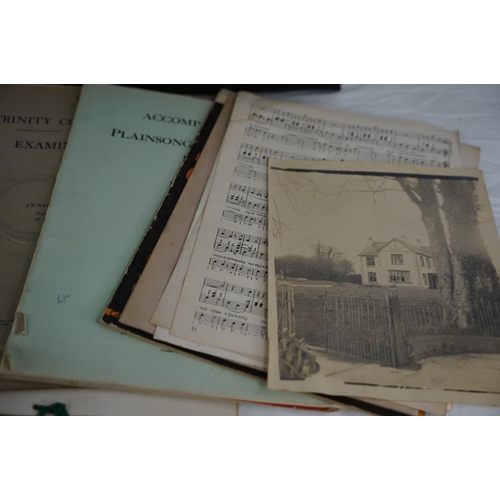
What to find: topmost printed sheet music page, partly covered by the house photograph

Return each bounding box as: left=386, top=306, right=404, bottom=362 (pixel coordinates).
left=163, top=93, right=462, bottom=366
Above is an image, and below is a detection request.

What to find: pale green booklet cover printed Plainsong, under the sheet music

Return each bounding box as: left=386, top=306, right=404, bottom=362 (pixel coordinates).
left=3, top=85, right=330, bottom=407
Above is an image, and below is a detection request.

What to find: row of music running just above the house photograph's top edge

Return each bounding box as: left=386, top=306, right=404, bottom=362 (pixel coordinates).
left=238, top=143, right=449, bottom=167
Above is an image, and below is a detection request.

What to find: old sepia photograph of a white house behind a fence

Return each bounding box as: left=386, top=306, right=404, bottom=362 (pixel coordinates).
left=269, top=160, right=500, bottom=406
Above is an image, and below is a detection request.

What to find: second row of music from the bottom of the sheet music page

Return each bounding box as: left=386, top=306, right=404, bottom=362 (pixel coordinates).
left=200, top=278, right=267, bottom=316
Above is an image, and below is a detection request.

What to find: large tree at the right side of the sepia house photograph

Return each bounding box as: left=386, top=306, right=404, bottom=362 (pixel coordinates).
left=382, top=178, right=500, bottom=328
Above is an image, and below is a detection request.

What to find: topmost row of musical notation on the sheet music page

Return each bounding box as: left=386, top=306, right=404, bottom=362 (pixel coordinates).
left=250, top=106, right=451, bottom=155
